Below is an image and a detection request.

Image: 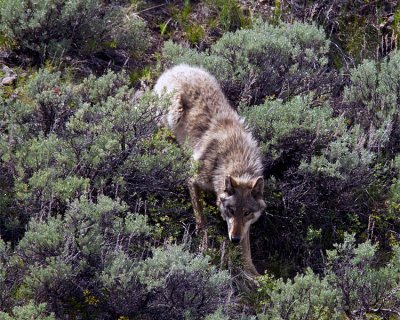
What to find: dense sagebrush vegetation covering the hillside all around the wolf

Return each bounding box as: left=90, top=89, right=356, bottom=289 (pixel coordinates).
left=0, top=0, right=400, bottom=320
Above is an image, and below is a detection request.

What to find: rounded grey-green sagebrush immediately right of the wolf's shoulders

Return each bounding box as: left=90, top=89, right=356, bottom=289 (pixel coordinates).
left=244, top=96, right=374, bottom=178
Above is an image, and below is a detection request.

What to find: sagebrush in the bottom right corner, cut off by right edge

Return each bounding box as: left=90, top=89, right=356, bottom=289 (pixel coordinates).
left=326, top=235, right=400, bottom=319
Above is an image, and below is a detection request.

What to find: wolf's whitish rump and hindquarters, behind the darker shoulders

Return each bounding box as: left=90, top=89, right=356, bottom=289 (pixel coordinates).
left=154, top=64, right=234, bottom=149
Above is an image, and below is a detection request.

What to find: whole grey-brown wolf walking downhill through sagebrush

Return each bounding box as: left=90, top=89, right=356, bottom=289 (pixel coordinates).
left=154, top=64, right=266, bottom=275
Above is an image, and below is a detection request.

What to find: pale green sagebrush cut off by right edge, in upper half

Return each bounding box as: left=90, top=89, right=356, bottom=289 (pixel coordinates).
left=344, top=51, right=400, bottom=155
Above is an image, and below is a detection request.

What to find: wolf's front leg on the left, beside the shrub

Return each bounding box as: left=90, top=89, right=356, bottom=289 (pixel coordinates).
left=189, top=178, right=208, bottom=252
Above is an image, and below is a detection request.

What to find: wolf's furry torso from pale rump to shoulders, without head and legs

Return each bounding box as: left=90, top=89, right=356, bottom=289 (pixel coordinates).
left=154, top=65, right=263, bottom=191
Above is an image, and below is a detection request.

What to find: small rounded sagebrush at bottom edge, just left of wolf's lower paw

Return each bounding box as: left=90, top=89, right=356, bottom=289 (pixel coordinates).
left=137, top=246, right=229, bottom=319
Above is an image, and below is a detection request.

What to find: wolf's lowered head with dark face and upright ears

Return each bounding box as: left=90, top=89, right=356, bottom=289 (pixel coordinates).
left=217, top=176, right=266, bottom=243
